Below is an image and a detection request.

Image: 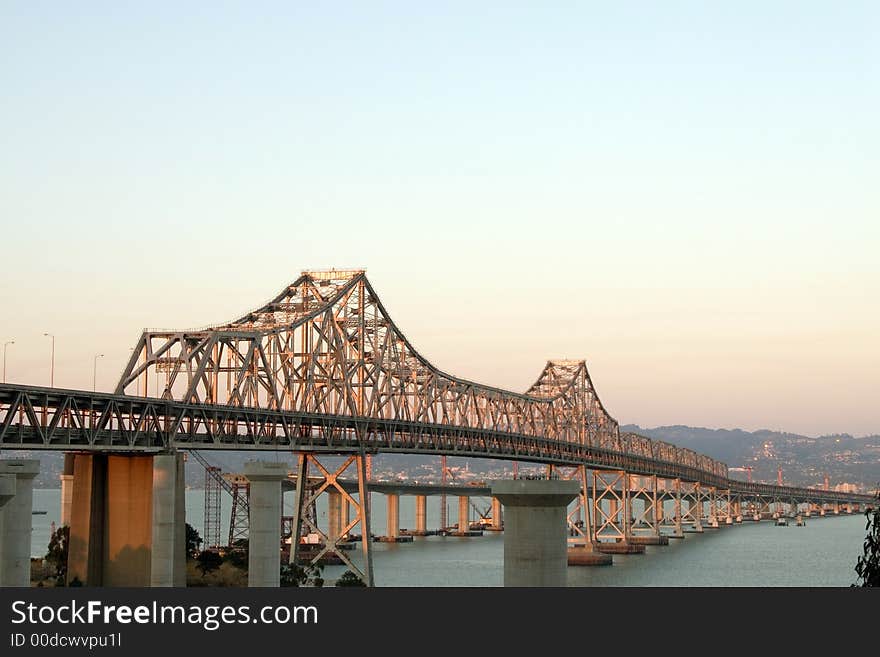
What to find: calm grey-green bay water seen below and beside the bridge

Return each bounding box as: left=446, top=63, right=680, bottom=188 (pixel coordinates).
left=31, top=489, right=866, bottom=587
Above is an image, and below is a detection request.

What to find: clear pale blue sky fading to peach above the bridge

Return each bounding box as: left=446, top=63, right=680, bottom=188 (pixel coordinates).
left=0, top=0, right=880, bottom=435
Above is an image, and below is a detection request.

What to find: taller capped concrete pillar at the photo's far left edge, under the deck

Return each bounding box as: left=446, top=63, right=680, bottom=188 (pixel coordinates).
left=0, top=459, right=40, bottom=587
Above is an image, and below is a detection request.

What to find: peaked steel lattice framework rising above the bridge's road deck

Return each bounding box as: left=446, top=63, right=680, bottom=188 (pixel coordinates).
left=108, top=270, right=727, bottom=477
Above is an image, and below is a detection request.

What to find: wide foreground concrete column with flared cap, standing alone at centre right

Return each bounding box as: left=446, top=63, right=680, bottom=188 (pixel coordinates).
left=492, top=479, right=580, bottom=586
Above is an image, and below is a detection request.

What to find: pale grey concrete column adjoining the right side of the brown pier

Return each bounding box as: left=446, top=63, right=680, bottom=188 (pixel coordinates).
left=150, top=454, right=186, bottom=587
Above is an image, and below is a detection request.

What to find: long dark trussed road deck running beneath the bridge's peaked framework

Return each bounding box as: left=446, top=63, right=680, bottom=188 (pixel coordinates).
left=0, top=384, right=874, bottom=504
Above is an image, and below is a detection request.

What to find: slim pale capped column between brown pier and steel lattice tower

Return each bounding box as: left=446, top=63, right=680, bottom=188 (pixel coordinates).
left=244, top=461, right=286, bottom=587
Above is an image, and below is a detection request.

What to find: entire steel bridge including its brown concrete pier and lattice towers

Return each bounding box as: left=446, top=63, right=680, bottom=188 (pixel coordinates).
left=0, top=270, right=873, bottom=585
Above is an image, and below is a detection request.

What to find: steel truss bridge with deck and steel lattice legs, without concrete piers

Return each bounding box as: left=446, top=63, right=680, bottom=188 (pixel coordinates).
left=0, top=270, right=872, bottom=582
